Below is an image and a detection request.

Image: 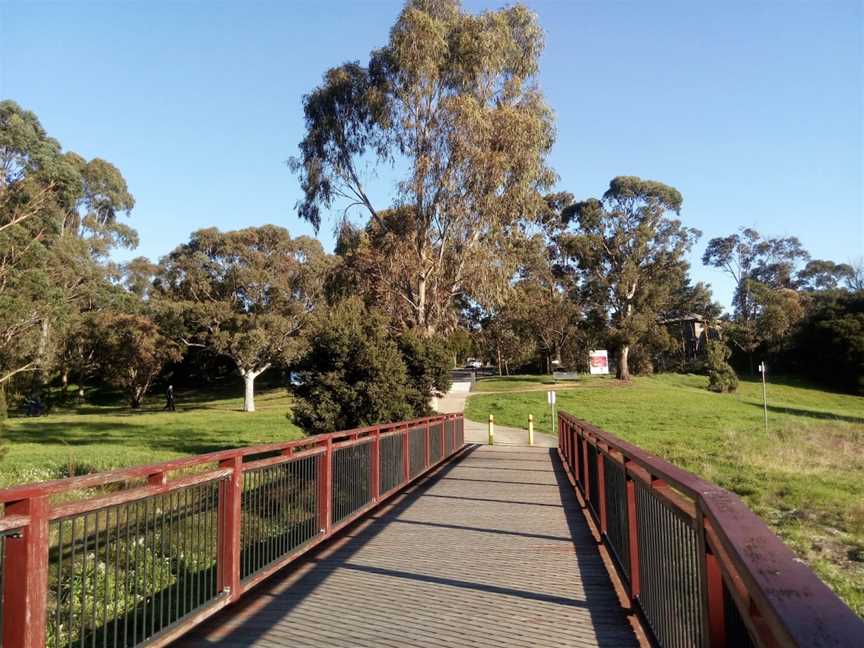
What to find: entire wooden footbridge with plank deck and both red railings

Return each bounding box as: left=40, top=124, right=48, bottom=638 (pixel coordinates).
left=0, top=413, right=864, bottom=648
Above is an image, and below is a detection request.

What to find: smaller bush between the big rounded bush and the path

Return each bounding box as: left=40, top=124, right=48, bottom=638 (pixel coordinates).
left=399, top=331, right=453, bottom=416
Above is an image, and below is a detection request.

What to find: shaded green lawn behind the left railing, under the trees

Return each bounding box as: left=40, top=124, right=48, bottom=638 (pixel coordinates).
left=0, top=380, right=303, bottom=487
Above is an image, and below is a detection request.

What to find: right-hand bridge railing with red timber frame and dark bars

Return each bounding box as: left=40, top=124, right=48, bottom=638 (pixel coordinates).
left=558, top=412, right=864, bottom=648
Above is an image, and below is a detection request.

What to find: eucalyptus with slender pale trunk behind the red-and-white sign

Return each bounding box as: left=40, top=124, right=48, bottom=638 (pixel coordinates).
left=556, top=176, right=701, bottom=380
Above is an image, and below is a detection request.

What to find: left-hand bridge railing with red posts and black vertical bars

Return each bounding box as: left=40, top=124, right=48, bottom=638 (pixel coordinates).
left=0, top=414, right=464, bottom=648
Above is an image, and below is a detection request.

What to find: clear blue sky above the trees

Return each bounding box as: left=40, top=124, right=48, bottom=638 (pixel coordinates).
left=0, top=0, right=864, bottom=305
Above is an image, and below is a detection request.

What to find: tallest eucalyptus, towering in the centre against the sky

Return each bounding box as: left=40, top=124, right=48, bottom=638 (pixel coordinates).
left=292, top=0, right=554, bottom=333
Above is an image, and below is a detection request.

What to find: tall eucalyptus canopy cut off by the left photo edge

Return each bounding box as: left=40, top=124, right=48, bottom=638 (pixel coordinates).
left=0, top=101, right=136, bottom=384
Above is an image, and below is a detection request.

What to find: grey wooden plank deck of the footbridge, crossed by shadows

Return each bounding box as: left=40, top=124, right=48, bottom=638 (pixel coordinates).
left=176, top=446, right=637, bottom=648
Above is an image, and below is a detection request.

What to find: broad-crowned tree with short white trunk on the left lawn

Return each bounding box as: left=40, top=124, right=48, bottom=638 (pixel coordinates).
left=151, top=225, right=329, bottom=412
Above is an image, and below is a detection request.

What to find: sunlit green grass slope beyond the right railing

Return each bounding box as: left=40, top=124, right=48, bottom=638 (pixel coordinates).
left=466, top=374, right=864, bottom=616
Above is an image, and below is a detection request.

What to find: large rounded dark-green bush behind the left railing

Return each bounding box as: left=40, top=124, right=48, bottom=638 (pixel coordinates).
left=293, top=298, right=413, bottom=433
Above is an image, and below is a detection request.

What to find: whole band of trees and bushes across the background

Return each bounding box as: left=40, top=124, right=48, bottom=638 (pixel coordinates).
left=0, top=0, right=864, bottom=431
